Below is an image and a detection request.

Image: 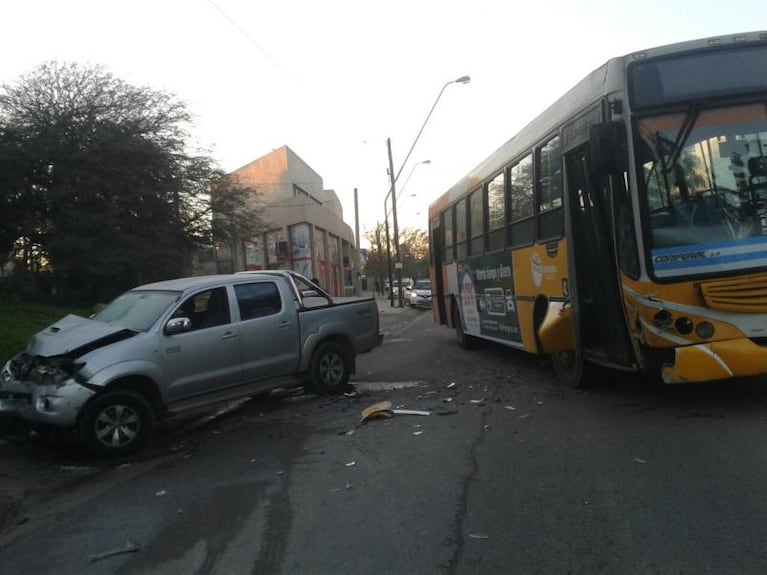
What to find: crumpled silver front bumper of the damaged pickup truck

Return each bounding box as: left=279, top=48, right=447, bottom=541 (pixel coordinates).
left=0, top=362, right=94, bottom=427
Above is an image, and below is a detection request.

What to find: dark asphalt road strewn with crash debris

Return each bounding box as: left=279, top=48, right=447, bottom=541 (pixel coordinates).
left=0, top=303, right=767, bottom=575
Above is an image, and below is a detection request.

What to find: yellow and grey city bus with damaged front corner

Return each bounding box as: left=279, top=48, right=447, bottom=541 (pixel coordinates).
left=429, top=32, right=767, bottom=387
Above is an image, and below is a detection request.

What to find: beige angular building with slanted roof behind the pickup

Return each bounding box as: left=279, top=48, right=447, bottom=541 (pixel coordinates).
left=216, top=146, right=356, bottom=296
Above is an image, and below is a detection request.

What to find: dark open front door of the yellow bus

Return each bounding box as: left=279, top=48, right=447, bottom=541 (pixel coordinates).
left=565, top=146, right=631, bottom=366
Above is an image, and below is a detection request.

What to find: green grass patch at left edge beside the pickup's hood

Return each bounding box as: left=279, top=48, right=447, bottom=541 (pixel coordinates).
left=0, top=294, right=93, bottom=366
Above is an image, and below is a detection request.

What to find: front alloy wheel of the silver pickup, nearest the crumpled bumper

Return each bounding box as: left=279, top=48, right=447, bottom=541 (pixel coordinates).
left=80, top=391, right=154, bottom=456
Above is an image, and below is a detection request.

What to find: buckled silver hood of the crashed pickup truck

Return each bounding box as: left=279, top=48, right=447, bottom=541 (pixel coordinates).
left=27, top=314, right=137, bottom=358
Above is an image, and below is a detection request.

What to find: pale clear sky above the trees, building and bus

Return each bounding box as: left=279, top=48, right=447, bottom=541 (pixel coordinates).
left=0, top=0, right=767, bottom=245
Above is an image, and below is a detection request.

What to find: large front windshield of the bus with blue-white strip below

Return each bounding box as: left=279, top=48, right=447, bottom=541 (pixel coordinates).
left=636, top=103, right=767, bottom=278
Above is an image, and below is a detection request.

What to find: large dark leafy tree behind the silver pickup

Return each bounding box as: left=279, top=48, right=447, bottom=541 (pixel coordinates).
left=0, top=62, right=264, bottom=301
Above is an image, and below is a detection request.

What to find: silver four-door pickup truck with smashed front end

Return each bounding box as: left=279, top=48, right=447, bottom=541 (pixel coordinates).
left=0, top=271, right=382, bottom=455
